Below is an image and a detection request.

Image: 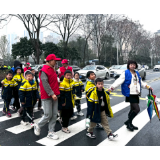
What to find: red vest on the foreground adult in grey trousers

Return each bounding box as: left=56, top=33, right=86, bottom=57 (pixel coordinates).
left=39, top=65, right=60, bottom=99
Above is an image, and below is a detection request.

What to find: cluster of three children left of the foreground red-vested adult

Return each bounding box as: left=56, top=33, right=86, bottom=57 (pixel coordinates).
left=1, top=67, right=41, bottom=128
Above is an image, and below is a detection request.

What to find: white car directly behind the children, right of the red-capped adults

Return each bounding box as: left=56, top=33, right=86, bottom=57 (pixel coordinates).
left=77, top=65, right=110, bottom=80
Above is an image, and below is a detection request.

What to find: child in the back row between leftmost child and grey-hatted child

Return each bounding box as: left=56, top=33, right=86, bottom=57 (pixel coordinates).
left=13, top=66, right=24, bottom=113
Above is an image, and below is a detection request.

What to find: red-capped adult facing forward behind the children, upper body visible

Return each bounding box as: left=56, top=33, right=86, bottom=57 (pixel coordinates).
left=58, top=59, right=74, bottom=78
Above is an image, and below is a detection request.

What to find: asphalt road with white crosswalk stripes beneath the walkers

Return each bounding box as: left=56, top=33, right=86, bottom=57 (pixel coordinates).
left=0, top=70, right=160, bottom=146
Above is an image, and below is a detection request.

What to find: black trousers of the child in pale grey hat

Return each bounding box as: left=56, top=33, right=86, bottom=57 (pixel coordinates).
left=22, top=107, right=33, bottom=123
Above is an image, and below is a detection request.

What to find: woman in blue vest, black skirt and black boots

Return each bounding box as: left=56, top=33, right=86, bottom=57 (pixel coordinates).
left=108, top=60, right=153, bottom=131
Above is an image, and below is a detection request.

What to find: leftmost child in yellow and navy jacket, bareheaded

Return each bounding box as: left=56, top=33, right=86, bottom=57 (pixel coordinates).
left=1, top=71, right=18, bottom=117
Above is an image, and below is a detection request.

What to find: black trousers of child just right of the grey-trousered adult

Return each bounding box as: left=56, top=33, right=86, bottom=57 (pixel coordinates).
left=61, top=108, right=73, bottom=128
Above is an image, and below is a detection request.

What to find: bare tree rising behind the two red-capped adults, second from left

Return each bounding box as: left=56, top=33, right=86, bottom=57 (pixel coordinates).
left=47, top=14, right=83, bottom=58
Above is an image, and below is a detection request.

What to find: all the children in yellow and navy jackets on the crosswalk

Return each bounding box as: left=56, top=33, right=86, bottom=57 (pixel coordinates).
left=1, top=64, right=117, bottom=139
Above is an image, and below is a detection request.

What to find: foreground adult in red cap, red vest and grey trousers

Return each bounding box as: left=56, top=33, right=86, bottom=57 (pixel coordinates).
left=34, top=54, right=61, bottom=140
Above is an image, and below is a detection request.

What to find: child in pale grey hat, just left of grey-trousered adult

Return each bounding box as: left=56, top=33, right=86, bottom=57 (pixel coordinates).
left=19, top=71, right=39, bottom=128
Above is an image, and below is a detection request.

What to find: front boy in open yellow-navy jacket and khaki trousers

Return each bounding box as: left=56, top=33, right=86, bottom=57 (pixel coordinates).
left=86, top=78, right=118, bottom=140
